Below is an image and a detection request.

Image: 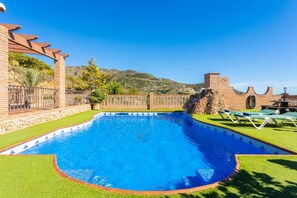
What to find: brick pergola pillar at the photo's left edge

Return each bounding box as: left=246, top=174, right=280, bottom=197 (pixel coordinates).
left=0, top=25, right=8, bottom=120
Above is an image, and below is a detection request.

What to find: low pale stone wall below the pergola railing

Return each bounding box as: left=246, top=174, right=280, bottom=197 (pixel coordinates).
left=0, top=104, right=90, bottom=134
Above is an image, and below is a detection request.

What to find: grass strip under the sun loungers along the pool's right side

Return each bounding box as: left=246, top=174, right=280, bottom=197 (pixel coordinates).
left=193, top=114, right=297, bottom=153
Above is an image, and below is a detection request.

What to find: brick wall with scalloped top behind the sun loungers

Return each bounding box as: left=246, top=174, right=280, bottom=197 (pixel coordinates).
left=204, top=73, right=281, bottom=110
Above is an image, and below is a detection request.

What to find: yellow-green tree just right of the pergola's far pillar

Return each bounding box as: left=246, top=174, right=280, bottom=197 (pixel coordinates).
left=76, top=58, right=109, bottom=90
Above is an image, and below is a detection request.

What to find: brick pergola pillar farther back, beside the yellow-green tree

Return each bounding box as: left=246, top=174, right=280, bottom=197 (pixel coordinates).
left=54, top=55, right=66, bottom=108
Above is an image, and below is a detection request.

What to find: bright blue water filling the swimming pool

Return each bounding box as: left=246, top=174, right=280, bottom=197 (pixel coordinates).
left=23, top=113, right=267, bottom=190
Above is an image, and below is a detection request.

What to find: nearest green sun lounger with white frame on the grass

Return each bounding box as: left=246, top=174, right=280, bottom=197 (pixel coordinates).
left=234, top=112, right=297, bottom=129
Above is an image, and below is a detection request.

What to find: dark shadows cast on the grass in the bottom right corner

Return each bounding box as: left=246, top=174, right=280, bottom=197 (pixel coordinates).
left=173, top=169, right=297, bottom=198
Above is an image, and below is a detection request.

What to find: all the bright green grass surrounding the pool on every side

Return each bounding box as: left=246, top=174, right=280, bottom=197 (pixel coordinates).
left=0, top=111, right=297, bottom=197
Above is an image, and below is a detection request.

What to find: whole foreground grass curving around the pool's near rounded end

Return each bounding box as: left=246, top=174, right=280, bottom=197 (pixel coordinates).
left=0, top=155, right=297, bottom=198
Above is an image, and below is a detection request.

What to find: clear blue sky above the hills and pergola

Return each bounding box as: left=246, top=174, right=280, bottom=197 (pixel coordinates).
left=0, top=0, right=297, bottom=94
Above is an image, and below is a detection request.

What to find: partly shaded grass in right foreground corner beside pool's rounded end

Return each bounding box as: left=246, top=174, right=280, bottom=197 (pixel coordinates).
left=188, top=155, right=297, bottom=198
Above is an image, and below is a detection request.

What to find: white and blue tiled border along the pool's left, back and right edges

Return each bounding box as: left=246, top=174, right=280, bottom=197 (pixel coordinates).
left=0, top=112, right=290, bottom=155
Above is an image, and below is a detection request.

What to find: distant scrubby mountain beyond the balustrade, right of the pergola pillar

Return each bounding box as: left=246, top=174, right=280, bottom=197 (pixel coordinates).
left=66, top=66, right=203, bottom=94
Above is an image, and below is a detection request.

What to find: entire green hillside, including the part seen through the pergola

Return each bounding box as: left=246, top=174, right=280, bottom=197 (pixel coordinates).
left=9, top=52, right=202, bottom=94
